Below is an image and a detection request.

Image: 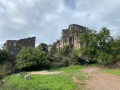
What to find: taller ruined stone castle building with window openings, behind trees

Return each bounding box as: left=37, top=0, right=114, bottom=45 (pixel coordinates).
left=56, top=24, right=87, bottom=50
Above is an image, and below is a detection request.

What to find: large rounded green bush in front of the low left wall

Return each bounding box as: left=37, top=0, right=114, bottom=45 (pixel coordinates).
left=16, top=47, right=49, bottom=69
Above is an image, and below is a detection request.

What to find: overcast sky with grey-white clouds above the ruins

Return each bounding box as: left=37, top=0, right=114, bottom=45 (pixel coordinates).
left=0, top=0, right=120, bottom=48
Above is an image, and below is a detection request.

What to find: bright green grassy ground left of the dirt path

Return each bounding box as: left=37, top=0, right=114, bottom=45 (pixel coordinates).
left=0, top=65, right=85, bottom=90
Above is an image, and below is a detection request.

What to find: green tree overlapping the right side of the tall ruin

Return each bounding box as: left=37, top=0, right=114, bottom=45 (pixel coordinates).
left=80, top=28, right=98, bottom=60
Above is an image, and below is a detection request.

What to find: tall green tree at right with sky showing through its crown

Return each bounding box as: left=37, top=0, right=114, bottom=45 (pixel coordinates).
left=97, top=27, right=115, bottom=64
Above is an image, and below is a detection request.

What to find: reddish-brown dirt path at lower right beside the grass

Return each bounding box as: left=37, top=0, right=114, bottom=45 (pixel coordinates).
left=83, top=66, right=120, bottom=90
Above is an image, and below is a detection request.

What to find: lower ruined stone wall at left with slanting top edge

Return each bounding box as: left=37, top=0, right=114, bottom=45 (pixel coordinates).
left=3, top=37, right=35, bottom=57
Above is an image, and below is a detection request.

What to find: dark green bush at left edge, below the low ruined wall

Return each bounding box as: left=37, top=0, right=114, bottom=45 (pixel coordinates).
left=0, top=50, right=10, bottom=64
